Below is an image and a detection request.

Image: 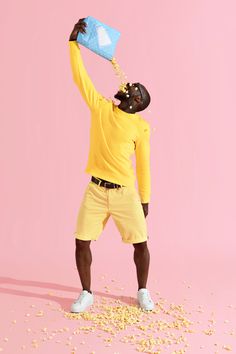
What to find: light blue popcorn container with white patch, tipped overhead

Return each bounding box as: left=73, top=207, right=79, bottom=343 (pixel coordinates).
left=76, top=16, right=120, bottom=60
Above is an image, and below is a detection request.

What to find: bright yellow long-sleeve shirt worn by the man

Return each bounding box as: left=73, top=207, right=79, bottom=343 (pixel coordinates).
left=69, top=41, right=151, bottom=203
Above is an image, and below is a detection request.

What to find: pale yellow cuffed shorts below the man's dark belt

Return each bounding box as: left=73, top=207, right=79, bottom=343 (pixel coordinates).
left=73, top=181, right=147, bottom=243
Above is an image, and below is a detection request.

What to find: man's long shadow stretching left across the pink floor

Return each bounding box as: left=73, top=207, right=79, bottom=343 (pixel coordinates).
left=0, top=277, right=137, bottom=311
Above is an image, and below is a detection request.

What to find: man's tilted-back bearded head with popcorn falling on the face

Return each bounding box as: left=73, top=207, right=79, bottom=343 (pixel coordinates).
left=114, top=83, right=151, bottom=113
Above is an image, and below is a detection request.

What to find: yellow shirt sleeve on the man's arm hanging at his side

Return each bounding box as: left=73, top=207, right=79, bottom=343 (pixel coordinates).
left=135, top=122, right=151, bottom=203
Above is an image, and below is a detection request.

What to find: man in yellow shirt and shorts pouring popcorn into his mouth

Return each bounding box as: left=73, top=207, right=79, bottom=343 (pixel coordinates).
left=69, top=19, right=154, bottom=313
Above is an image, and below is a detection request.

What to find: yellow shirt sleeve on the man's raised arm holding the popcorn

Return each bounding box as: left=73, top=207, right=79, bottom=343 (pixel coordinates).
left=69, top=41, right=105, bottom=109
